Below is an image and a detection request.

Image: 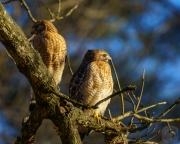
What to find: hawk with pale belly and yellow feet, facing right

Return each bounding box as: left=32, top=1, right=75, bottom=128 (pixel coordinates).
left=69, top=49, right=113, bottom=139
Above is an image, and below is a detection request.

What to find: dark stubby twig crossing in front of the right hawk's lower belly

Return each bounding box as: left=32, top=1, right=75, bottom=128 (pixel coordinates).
left=92, top=86, right=136, bottom=109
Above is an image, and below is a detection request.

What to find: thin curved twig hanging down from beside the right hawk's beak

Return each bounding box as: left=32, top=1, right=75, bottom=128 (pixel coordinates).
left=111, top=60, right=124, bottom=115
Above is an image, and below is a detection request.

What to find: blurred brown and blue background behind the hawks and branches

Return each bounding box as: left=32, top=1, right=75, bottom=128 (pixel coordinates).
left=0, top=0, right=180, bottom=144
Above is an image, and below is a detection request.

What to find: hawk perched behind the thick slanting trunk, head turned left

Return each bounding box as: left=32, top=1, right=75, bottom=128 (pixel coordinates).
left=29, top=20, right=67, bottom=112
